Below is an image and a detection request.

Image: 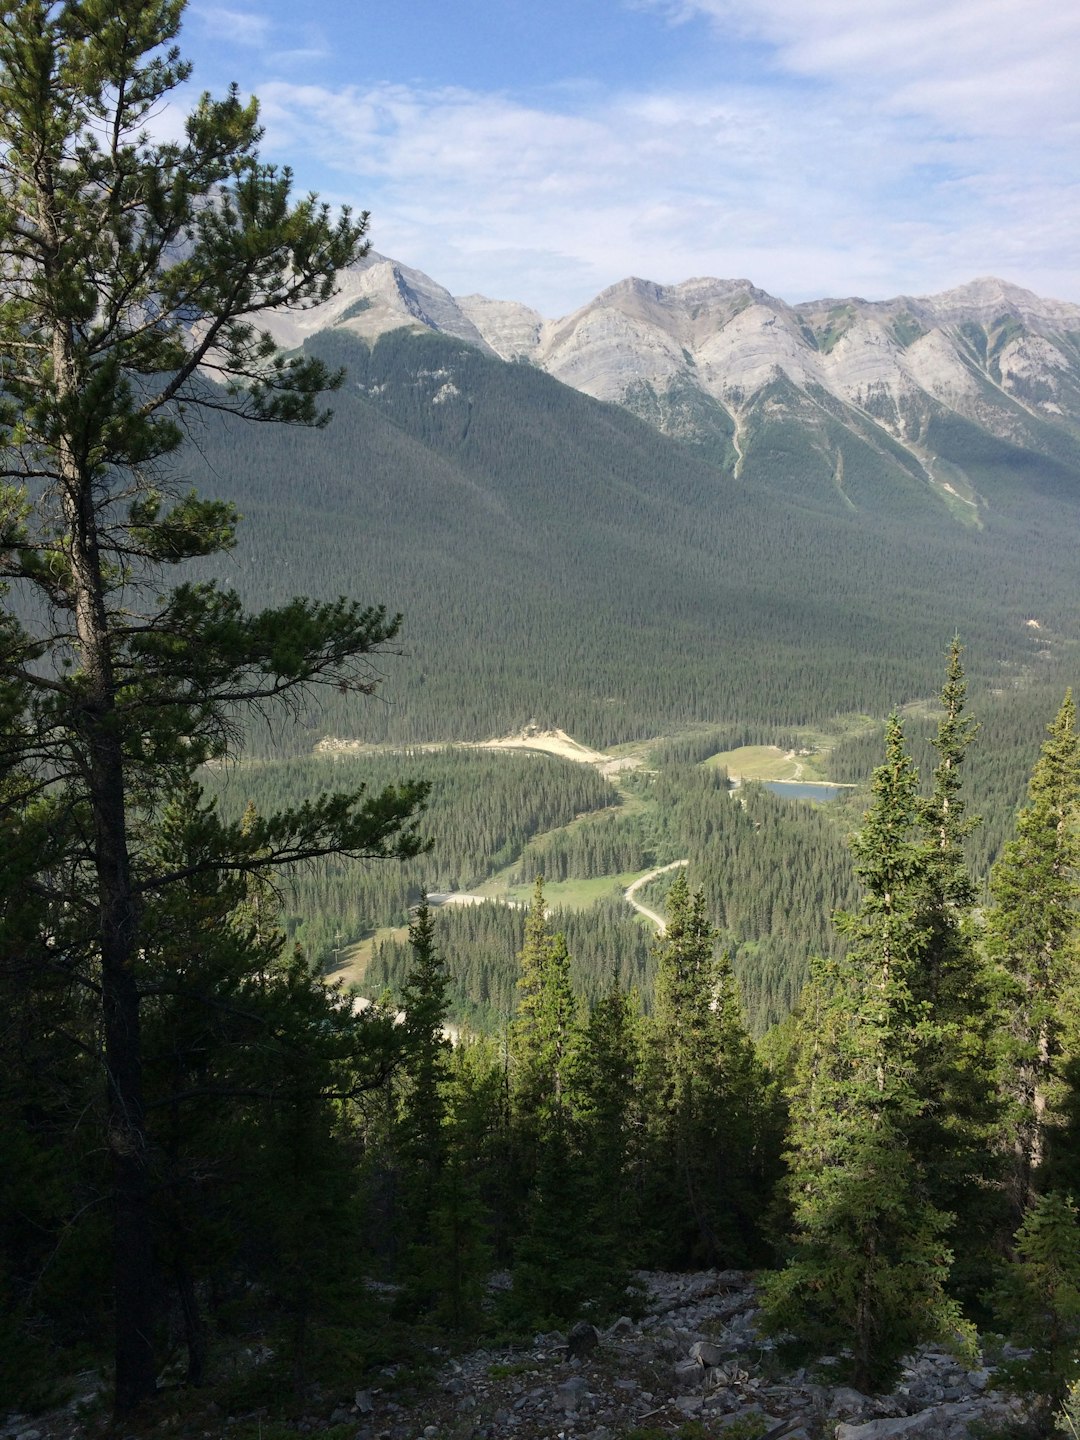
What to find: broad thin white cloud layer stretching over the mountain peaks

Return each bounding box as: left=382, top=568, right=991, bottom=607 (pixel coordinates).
left=220, top=0, right=1080, bottom=315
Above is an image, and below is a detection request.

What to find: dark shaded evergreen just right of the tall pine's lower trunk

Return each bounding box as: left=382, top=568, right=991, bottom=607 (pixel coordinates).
left=138, top=785, right=403, bottom=1385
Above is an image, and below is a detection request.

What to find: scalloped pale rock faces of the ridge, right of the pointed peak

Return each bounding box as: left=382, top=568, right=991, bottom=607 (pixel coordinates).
left=509, top=270, right=1080, bottom=455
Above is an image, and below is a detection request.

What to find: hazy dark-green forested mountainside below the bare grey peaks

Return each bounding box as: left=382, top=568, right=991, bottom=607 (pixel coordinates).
left=190, top=333, right=1080, bottom=747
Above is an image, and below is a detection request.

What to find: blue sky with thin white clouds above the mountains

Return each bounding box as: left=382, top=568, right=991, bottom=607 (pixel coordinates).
left=180, top=0, right=1080, bottom=318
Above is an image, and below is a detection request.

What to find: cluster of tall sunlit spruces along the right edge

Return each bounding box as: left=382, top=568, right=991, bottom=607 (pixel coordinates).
left=765, top=665, right=1080, bottom=1416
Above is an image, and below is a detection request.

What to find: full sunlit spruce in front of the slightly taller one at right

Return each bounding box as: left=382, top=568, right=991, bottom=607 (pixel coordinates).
left=766, top=716, right=979, bottom=1388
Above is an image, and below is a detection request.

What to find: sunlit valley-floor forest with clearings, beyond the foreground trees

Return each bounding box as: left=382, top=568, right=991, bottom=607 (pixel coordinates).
left=207, top=662, right=1077, bottom=1034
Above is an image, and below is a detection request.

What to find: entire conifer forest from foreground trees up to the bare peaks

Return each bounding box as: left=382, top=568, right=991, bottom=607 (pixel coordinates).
left=0, top=0, right=1080, bottom=1436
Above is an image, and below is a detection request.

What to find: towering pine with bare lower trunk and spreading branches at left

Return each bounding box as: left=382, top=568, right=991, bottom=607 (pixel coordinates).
left=0, top=0, right=420, bottom=1413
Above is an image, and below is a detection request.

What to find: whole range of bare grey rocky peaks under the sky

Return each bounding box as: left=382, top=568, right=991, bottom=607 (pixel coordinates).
left=266, top=253, right=1080, bottom=526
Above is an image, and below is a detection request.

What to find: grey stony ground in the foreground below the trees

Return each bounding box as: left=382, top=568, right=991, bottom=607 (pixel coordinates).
left=0, top=1270, right=1042, bottom=1440
